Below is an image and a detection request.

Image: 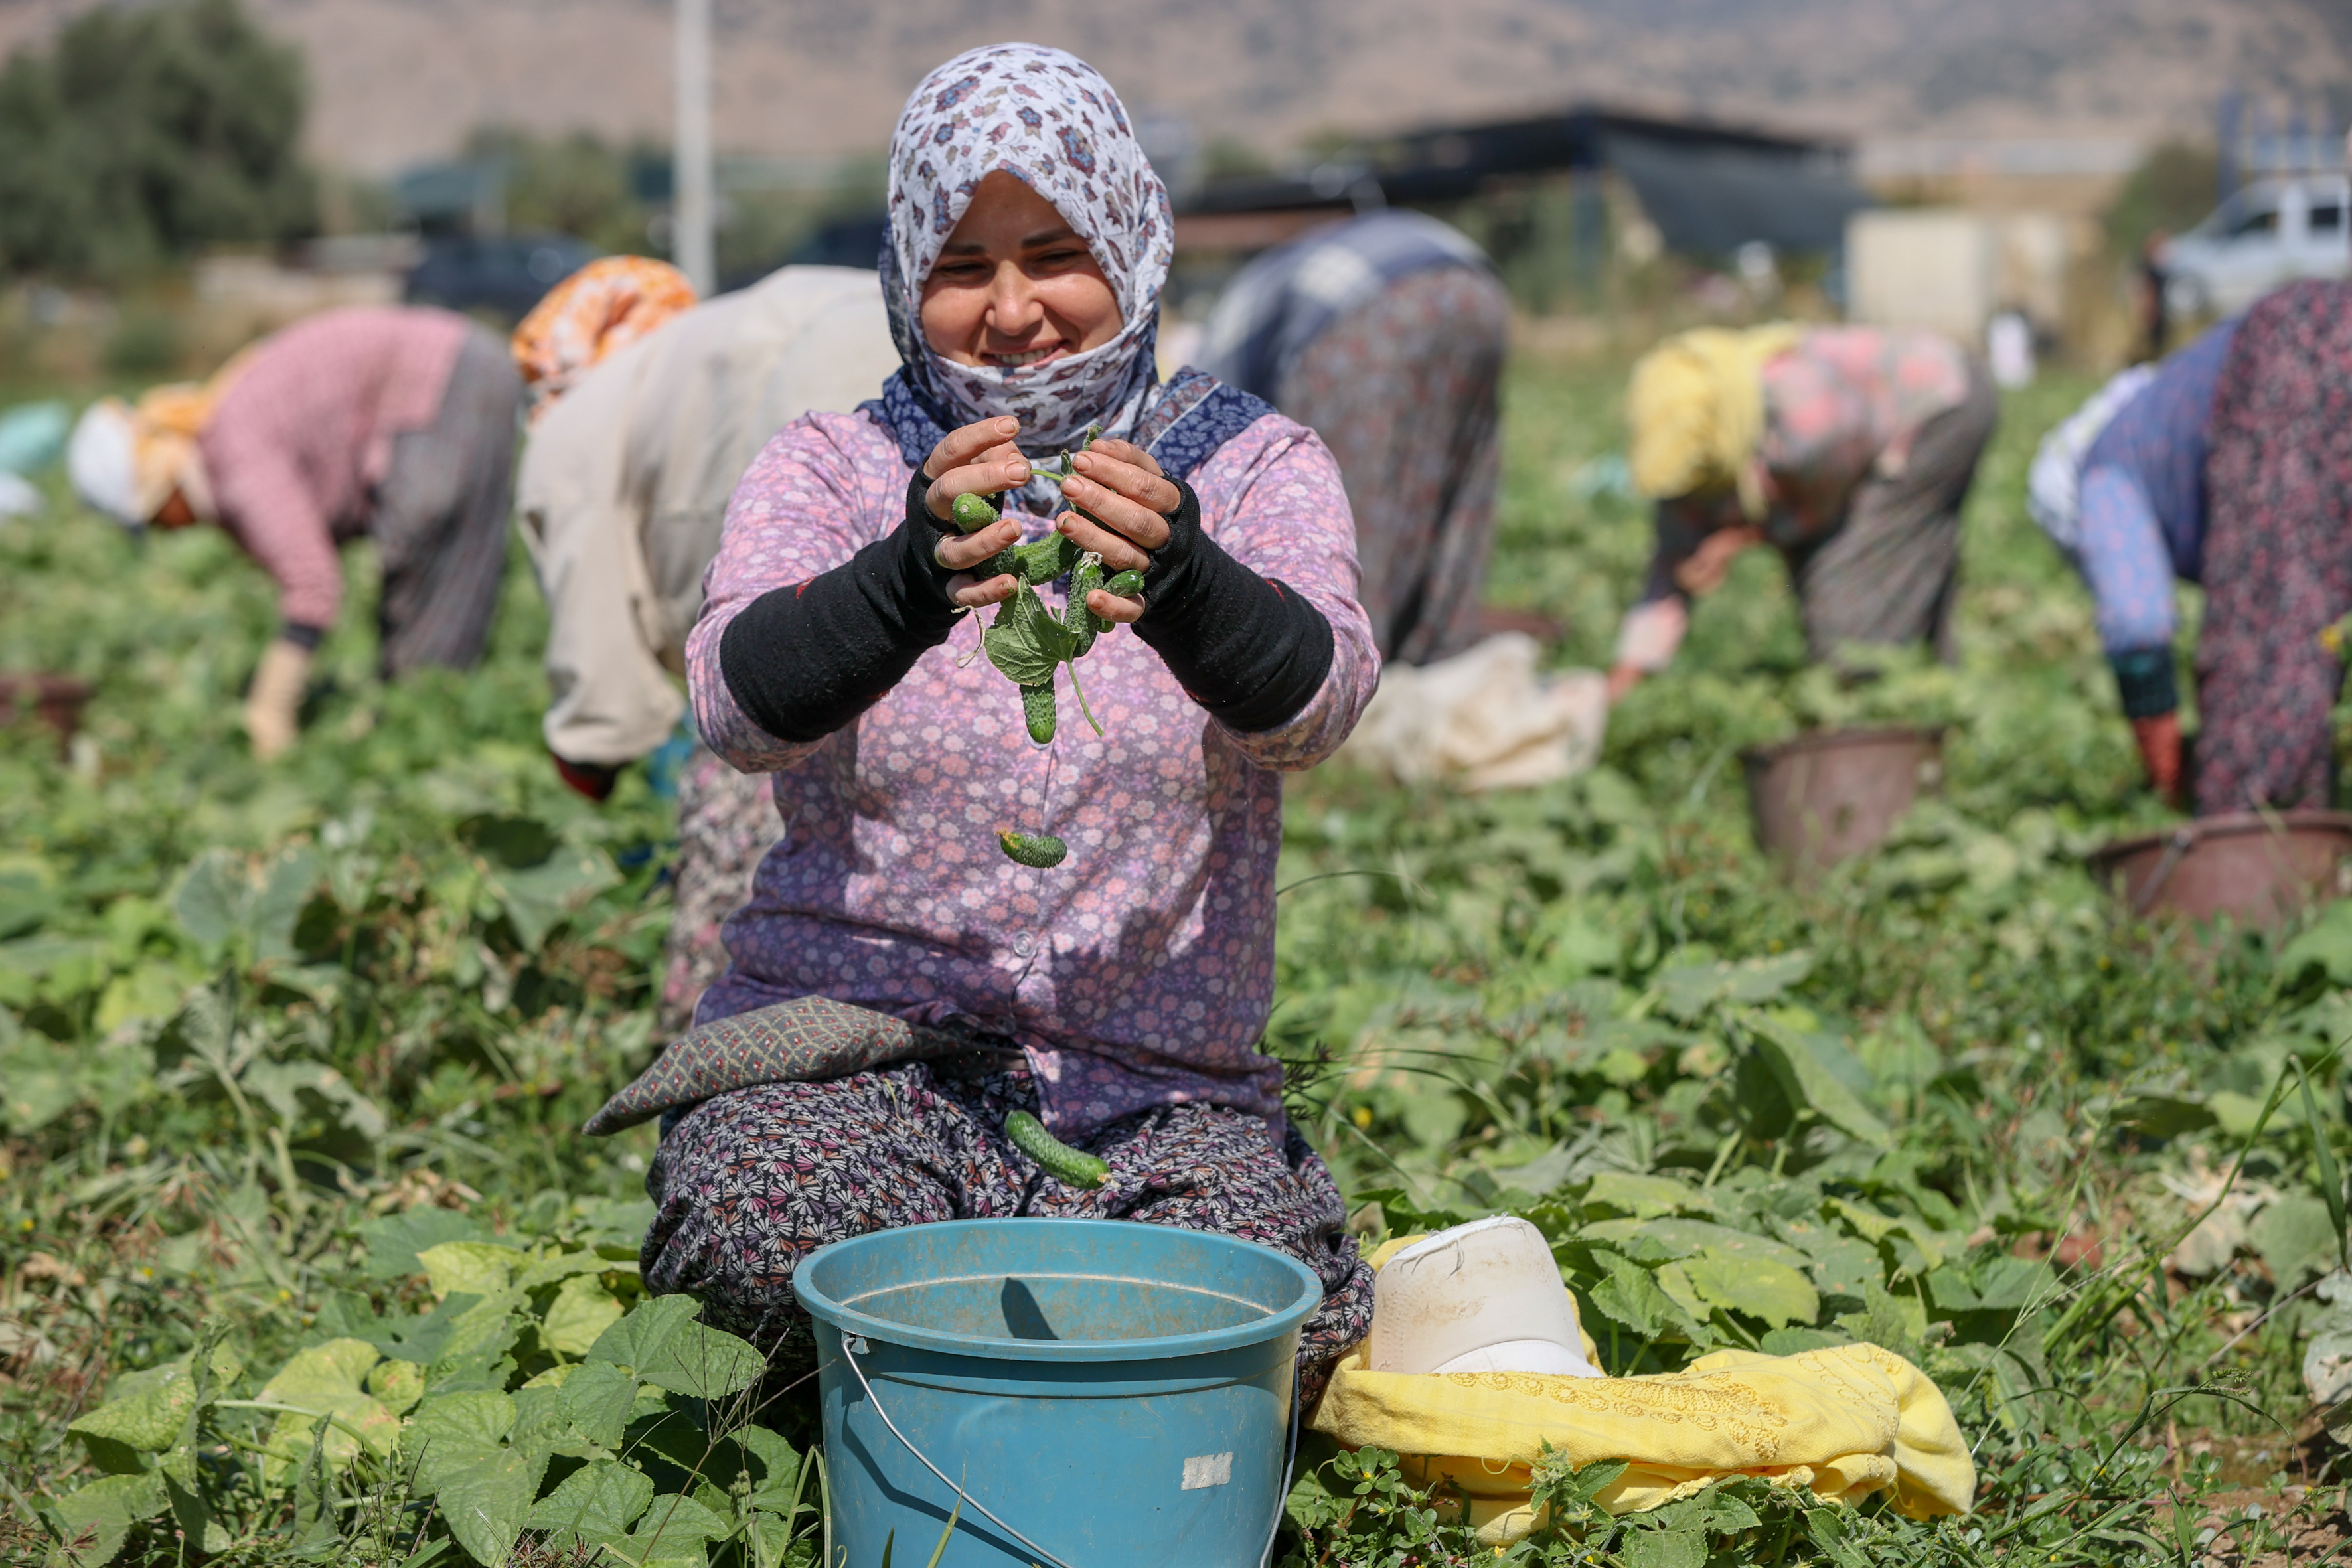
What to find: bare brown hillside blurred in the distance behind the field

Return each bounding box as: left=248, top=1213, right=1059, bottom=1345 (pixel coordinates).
left=0, top=0, right=2352, bottom=172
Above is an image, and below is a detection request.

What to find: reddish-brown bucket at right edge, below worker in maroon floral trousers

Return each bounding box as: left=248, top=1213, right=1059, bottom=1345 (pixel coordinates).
left=2091, top=811, right=2352, bottom=929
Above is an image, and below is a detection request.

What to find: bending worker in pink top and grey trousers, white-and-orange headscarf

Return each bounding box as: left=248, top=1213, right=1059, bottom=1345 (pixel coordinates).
left=66, top=308, right=522, bottom=759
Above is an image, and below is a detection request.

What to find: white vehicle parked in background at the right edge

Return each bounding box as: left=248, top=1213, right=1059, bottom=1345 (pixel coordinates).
left=2157, top=174, right=2352, bottom=315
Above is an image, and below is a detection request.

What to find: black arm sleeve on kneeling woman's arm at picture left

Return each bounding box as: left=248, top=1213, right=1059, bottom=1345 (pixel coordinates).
left=720, top=468, right=955, bottom=743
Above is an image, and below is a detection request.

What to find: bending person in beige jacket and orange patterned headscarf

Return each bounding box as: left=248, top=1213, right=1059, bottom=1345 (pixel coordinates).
left=515, top=259, right=898, bottom=1028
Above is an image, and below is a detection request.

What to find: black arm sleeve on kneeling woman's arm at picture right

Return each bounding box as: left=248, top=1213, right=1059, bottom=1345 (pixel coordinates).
left=1136, top=479, right=1334, bottom=734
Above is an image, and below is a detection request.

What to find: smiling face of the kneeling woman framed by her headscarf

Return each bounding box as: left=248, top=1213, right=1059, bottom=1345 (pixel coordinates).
left=922, top=169, right=1122, bottom=369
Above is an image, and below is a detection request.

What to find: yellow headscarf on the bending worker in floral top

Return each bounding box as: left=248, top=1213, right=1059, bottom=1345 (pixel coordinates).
left=1625, top=322, right=1804, bottom=522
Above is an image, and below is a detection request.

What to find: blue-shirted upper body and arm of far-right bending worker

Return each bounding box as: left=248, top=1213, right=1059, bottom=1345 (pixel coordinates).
left=2025, top=320, right=2239, bottom=802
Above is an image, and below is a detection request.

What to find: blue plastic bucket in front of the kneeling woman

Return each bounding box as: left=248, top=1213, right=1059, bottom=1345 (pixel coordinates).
left=793, top=1220, right=1322, bottom=1568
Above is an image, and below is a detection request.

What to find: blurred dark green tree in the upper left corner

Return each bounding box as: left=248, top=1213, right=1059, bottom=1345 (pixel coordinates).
left=0, top=0, right=317, bottom=278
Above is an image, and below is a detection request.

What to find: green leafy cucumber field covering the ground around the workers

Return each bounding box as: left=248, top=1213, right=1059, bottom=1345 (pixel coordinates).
left=0, top=355, right=2352, bottom=1568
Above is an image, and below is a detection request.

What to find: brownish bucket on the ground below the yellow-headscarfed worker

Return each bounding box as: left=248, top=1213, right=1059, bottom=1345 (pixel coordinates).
left=1741, top=729, right=1943, bottom=877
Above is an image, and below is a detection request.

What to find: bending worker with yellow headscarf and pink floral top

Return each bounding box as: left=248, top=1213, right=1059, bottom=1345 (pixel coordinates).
left=1608, top=325, right=1997, bottom=700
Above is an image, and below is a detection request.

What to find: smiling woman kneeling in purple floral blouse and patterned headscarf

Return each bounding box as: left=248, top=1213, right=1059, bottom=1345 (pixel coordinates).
left=645, top=44, right=1378, bottom=1396
